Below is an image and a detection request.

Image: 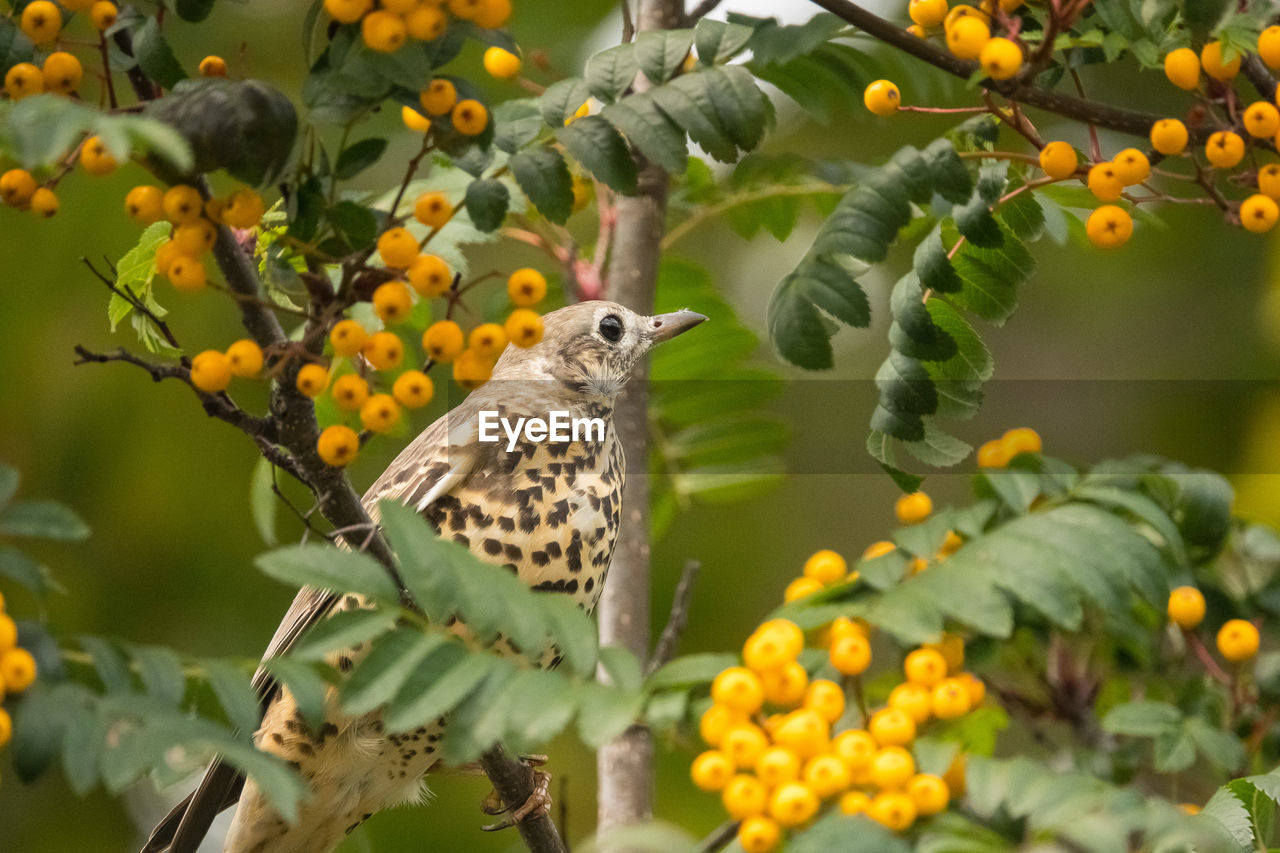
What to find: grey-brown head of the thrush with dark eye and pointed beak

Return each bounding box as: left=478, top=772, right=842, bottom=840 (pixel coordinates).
left=493, top=301, right=707, bottom=398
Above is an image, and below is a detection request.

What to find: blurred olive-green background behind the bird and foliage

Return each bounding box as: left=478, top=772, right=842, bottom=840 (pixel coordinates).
left=0, top=0, right=1280, bottom=853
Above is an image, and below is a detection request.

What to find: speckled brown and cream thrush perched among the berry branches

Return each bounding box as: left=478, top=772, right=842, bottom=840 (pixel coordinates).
left=142, top=300, right=707, bottom=853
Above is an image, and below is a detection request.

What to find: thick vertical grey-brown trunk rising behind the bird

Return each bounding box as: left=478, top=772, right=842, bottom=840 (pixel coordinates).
left=596, top=0, right=685, bottom=831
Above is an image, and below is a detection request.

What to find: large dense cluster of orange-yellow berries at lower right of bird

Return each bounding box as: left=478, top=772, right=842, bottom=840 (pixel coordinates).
left=691, top=492, right=986, bottom=853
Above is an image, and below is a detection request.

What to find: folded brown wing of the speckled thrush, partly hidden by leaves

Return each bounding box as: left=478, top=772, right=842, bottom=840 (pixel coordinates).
left=142, top=398, right=476, bottom=853
